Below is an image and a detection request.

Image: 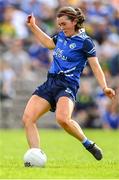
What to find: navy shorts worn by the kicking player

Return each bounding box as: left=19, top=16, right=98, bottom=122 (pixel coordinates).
left=33, top=74, right=79, bottom=112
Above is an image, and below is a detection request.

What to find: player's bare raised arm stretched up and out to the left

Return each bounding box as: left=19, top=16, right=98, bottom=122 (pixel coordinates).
left=27, top=14, right=55, bottom=49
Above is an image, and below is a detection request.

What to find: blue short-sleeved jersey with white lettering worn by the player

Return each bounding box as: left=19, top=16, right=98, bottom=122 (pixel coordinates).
left=49, top=29, right=96, bottom=83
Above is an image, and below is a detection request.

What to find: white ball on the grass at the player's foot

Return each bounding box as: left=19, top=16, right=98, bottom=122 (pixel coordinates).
left=24, top=148, right=47, bottom=167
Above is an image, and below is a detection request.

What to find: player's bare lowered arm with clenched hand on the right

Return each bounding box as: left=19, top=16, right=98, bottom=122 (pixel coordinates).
left=88, top=57, right=115, bottom=98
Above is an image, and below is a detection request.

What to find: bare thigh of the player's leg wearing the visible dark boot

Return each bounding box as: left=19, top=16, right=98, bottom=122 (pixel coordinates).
left=56, top=96, right=74, bottom=121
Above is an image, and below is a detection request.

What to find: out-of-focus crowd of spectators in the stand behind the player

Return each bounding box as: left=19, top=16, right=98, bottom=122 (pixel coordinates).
left=0, top=0, right=119, bottom=129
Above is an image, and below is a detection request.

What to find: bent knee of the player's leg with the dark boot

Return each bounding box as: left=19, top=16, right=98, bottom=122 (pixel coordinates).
left=56, top=114, right=68, bottom=127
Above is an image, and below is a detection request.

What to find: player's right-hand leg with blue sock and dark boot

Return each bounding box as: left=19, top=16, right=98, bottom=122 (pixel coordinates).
left=56, top=97, right=102, bottom=160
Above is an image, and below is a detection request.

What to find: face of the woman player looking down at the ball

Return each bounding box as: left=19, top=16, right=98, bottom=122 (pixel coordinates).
left=57, top=16, right=77, bottom=37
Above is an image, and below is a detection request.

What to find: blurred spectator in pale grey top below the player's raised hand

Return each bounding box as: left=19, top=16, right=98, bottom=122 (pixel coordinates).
left=3, top=39, right=31, bottom=78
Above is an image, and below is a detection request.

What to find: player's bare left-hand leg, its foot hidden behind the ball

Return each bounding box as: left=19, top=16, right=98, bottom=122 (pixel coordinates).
left=22, top=95, right=50, bottom=148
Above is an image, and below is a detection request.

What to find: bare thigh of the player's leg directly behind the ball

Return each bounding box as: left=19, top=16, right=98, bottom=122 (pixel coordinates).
left=23, top=95, right=51, bottom=122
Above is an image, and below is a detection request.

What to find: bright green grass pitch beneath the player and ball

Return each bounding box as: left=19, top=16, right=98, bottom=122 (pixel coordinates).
left=0, top=129, right=119, bottom=180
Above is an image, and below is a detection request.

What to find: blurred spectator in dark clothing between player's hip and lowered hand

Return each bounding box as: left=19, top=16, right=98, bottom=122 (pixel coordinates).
left=74, top=80, right=100, bottom=127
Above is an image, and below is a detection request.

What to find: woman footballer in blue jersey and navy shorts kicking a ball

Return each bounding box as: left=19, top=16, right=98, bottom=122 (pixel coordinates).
left=23, top=7, right=115, bottom=160
